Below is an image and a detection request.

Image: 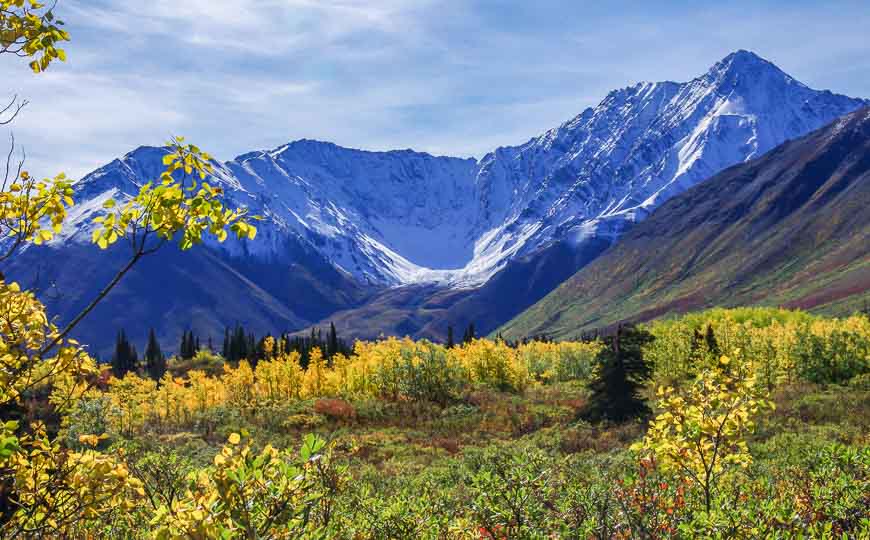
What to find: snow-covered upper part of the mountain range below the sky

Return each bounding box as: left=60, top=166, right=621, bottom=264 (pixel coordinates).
left=52, top=51, right=866, bottom=287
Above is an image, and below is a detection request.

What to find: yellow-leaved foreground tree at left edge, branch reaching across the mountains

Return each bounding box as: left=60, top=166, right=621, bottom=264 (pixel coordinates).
left=0, top=0, right=256, bottom=538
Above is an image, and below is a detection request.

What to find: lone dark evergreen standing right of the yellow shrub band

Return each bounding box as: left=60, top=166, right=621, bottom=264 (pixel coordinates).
left=584, top=325, right=654, bottom=423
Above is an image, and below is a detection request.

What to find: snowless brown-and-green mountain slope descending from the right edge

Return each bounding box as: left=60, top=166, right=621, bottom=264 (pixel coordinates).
left=502, top=108, right=870, bottom=338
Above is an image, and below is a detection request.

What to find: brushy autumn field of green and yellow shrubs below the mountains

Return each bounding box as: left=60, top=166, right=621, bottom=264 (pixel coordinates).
left=13, top=309, right=870, bottom=538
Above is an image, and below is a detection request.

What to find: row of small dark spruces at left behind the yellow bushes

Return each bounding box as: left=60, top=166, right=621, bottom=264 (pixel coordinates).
left=111, top=323, right=353, bottom=380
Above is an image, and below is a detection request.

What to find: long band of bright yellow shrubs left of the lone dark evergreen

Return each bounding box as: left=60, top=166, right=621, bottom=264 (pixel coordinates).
left=95, top=338, right=603, bottom=434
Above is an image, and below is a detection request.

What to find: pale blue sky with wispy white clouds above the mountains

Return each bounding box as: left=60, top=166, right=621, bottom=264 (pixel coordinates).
left=0, top=0, right=870, bottom=178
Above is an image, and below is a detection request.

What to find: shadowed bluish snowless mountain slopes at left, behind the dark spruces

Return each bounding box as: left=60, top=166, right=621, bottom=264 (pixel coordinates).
left=4, top=240, right=369, bottom=359
